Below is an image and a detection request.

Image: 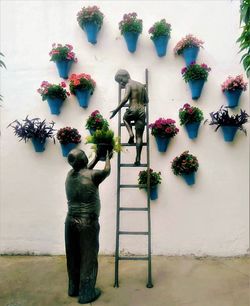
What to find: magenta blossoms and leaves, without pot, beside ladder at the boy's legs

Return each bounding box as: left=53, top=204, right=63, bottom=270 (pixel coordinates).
left=149, top=118, right=179, bottom=137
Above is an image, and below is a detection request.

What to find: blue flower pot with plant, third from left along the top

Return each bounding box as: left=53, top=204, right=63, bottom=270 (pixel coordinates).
left=148, top=19, right=171, bottom=57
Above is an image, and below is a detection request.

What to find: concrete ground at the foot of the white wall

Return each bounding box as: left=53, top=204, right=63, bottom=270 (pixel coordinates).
left=0, top=256, right=250, bottom=306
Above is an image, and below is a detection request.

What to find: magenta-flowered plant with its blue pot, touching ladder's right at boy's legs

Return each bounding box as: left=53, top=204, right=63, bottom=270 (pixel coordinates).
left=149, top=118, right=179, bottom=152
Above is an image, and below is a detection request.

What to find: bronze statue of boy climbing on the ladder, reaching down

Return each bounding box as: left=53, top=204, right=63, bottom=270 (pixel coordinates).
left=110, top=69, right=148, bottom=166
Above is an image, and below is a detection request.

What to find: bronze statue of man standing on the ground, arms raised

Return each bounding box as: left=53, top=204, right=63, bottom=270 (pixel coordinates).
left=65, top=149, right=110, bottom=304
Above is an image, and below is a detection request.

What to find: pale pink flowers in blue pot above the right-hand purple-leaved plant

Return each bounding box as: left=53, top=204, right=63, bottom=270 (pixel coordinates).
left=221, top=75, right=247, bottom=108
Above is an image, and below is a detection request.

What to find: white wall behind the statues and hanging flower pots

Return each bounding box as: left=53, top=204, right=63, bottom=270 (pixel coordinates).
left=0, top=0, right=249, bottom=256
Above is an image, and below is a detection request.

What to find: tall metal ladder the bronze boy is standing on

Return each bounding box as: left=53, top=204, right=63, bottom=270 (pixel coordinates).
left=114, top=69, right=153, bottom=288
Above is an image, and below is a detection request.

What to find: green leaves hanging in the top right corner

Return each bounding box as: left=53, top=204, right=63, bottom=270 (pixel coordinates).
left=237, top=0, right=250, bottom=77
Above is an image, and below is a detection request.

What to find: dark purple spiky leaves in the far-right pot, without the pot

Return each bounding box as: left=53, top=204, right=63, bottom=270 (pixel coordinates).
left=209, top=106, right=249, bottom=134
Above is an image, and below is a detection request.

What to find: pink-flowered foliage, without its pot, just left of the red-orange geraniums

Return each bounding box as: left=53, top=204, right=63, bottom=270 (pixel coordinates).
left=37, top=81, right=70, bottom=101
